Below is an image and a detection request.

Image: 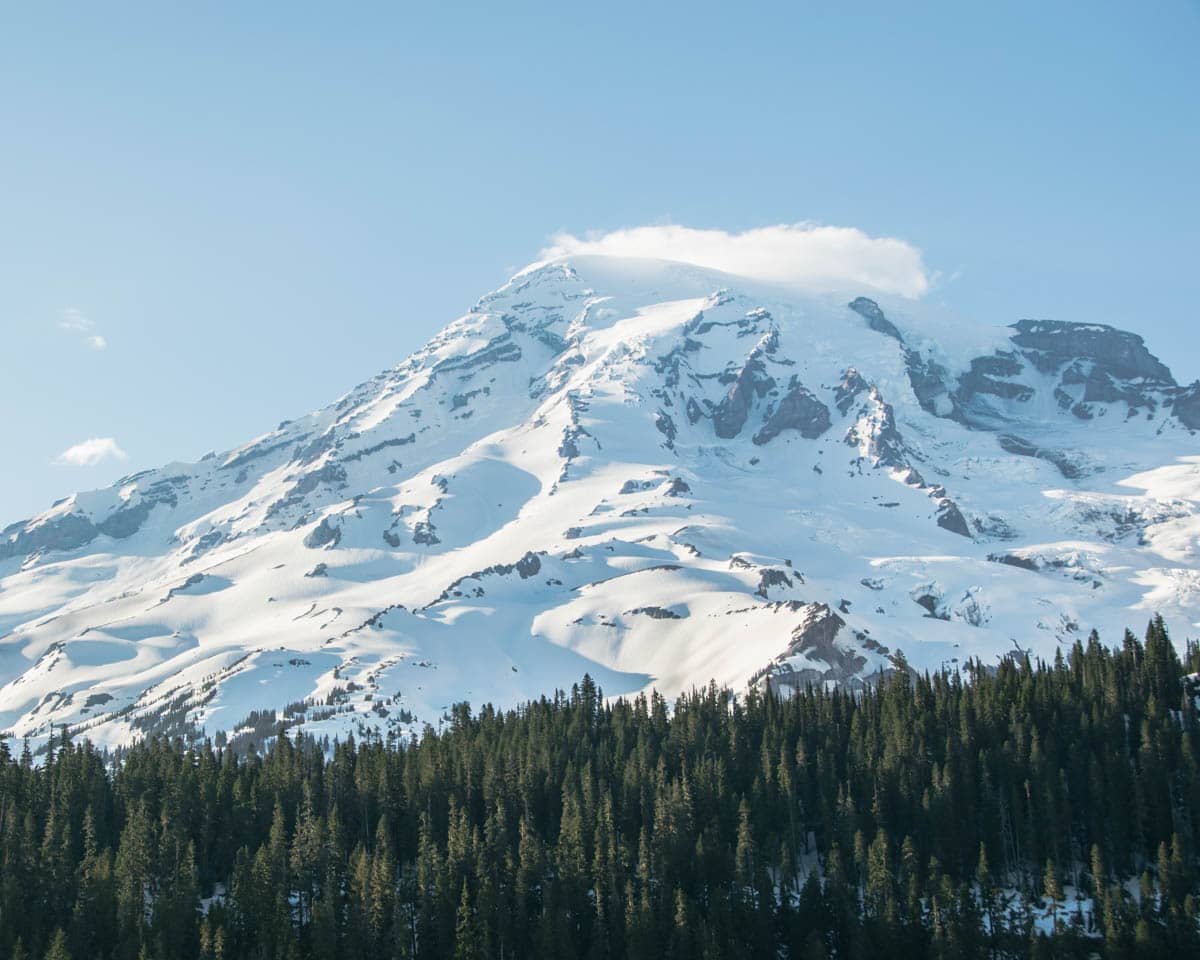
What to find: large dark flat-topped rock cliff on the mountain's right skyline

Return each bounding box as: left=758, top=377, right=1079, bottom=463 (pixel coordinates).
left=1012, top=320, right=1175, bottom=386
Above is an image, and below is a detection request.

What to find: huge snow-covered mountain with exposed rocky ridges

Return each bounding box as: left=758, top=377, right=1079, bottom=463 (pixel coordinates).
left=0, top=256, right=1200, bottom=745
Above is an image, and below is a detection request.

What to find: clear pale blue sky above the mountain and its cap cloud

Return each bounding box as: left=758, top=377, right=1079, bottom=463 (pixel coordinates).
left=0, top=0, right=1200, bottom=524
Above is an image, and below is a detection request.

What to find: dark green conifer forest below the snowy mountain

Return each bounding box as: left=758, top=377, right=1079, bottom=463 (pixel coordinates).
left=0, top=620, right=1200, bottom=960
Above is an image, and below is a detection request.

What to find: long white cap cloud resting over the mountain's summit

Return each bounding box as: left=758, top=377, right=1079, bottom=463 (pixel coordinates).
left=541, top=223, right=931, bottom=298
